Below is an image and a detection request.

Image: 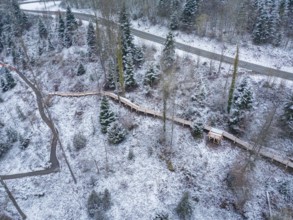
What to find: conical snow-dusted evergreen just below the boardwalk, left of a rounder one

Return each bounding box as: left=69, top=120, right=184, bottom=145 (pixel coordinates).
left=100, top=96, right=116, bottom=133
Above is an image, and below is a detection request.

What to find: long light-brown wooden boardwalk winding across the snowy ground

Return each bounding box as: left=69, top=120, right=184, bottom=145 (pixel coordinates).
left=48, top=91, right=293, bottom=170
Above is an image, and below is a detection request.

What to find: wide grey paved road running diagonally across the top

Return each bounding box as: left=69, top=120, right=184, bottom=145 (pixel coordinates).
left=24, top=10, right=293, bottom=81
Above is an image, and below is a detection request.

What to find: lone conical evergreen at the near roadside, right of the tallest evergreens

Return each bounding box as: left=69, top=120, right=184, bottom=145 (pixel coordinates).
left=162, top=32, right=175, bottom=69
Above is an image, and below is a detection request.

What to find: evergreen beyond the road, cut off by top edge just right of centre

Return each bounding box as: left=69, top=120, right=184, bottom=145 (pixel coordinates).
left=181, top=0, right=199, bottom=30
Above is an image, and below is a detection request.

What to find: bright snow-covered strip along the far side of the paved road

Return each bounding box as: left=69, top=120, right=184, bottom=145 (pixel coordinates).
left=21, top=1, right=293, bottom=73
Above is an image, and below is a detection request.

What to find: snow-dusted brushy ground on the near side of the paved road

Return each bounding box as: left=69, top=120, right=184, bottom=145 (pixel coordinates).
left=0, top=2, right=293, bottom=220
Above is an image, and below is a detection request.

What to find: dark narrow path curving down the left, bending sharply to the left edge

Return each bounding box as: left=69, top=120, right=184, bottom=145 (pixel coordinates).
left=0, top=63, right=59, bottom=180
